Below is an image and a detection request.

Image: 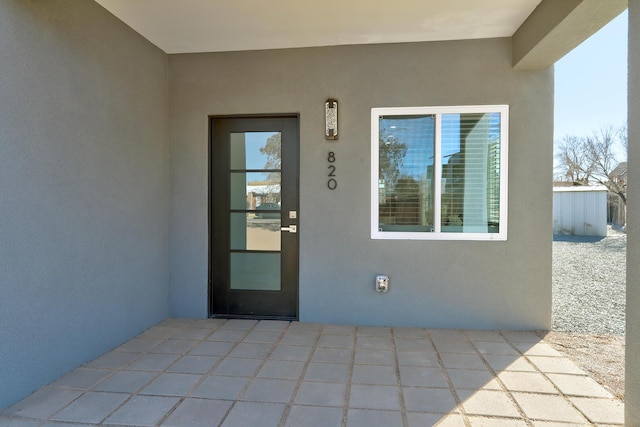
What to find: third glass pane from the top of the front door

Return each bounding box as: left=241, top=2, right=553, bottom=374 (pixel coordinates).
left=231, top=211, right=280, bottom=251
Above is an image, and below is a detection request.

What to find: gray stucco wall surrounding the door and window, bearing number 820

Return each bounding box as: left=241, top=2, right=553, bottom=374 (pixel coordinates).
left=169, top=39, right=553, bottom=329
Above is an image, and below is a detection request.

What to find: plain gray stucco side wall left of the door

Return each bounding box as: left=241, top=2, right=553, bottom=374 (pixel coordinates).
left=0, top=0, right=169, bottom=408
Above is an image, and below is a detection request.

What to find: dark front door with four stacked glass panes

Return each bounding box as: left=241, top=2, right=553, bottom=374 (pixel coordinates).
left=209, top=117, right=298, bottom=318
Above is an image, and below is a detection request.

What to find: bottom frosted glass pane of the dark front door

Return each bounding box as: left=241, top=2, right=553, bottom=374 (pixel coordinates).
left=230, top=253, right=280, bottom=291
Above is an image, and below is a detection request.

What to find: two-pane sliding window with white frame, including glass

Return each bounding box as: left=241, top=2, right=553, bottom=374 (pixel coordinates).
left=371, top=105, right=508, bottom=240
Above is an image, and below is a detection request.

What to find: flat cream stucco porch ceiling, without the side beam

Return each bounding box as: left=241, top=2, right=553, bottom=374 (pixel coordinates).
left=96, top=0, right=541, bottom=53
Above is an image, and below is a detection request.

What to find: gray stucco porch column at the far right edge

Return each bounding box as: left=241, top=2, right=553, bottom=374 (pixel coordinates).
left=625, top=0, right=640, bottom=426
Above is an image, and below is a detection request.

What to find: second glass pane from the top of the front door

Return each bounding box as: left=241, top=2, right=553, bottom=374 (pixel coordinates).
left=231, top=172, right=280, bottom=210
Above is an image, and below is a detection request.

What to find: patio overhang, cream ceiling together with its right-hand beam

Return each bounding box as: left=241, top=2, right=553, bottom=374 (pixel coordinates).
left=96, top=0, right=628, bottom=70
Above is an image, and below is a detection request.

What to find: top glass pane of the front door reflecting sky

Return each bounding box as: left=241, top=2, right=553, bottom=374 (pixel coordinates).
left=231, top=132, right=281, bottom=170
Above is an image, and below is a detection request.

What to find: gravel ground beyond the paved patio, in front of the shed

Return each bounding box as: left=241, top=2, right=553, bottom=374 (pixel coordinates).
left=540, top=228, right=627, bottom=399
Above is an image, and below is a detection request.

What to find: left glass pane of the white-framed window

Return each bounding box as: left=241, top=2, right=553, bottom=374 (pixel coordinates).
left=378, top=115, right=435, bottom=232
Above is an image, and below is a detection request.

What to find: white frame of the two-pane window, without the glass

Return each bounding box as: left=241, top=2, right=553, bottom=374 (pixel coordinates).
left=371, top=105, right=509, bottom=241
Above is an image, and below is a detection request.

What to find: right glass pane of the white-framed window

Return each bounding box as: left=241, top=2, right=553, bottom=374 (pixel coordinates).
left=440, top=113, right=500, bottom=233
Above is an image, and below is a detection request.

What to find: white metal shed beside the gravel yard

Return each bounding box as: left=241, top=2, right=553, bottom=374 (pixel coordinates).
left=553, top=186, right=607, bottom=237
